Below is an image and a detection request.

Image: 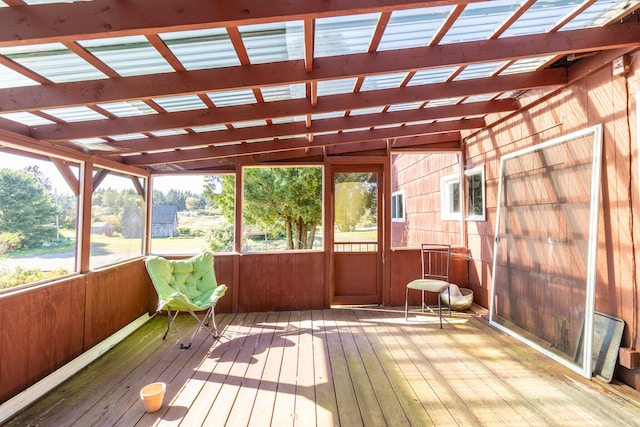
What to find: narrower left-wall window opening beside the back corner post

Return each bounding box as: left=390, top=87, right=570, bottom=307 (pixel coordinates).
left=89, top=169, right=145, bottom=269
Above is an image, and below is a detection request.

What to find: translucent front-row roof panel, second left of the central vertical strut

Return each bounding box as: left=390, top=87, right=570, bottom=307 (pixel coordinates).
left=160, top=28, right=240, bottom=70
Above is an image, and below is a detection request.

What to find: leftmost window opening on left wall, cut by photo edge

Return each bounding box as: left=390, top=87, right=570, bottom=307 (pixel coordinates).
left=0, top=152, right=80, bottom=289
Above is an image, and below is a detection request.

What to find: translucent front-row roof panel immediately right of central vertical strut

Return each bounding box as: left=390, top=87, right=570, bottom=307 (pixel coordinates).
left=314, top=13, right=380, bottom=58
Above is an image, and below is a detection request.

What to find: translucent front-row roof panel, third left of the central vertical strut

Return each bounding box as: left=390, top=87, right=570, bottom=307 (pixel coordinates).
left=78, top=36, right=174, bottom=77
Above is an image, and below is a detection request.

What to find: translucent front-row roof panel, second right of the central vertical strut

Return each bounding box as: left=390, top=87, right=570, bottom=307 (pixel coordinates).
left=378, top=6, right=452, bottom=51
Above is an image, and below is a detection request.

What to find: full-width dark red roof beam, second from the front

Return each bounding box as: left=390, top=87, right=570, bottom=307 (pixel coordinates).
left=6, top=22, right=640, bottom=112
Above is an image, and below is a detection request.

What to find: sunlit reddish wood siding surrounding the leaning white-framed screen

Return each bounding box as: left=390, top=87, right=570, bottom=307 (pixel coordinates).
left=465, top=54, right=640, bottom=388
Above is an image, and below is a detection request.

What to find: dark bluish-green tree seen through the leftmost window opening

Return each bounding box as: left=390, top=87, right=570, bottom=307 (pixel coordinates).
left=0, top=169, right=56, bottom=247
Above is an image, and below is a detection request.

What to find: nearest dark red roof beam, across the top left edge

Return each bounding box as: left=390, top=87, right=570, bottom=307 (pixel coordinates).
left=0, top=0, right=480, bottom=46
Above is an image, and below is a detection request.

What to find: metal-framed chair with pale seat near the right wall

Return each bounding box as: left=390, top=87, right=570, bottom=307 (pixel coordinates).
left=404, top=243, right=451, bottom=329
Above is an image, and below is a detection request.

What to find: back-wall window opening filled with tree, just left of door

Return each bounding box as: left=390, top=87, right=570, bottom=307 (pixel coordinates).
left=241, top=166, right=322, bottom=252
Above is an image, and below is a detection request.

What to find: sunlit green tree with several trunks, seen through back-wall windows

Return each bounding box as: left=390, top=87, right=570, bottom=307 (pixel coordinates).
left=205, top=167, right=322, bottom=249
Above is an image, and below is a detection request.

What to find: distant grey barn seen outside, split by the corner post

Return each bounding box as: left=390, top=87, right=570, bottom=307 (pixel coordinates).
left=122, top=206, right=178, bottom=238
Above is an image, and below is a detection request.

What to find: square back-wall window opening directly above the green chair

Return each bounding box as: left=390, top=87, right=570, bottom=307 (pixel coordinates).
left=151, top=175, right=235, bottom=254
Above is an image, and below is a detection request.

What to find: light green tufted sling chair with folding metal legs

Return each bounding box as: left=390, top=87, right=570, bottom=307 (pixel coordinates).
left=146, top=252, right=227, bottom=350
